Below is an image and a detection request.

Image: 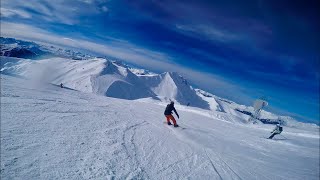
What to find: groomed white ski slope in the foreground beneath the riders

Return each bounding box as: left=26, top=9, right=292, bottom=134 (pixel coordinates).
left=1, top=74, right=319, bottom=180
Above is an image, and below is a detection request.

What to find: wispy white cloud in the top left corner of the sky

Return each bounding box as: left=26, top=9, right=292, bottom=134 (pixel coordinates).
left=1, top=0, right=108, bottom=25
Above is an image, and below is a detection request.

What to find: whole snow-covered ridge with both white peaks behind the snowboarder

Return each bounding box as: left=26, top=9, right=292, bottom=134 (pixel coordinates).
left=1, top=57, right=209, bottom=109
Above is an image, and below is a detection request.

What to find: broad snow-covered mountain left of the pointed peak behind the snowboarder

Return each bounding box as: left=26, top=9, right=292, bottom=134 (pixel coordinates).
left=1, top=58, right=156, bottom=100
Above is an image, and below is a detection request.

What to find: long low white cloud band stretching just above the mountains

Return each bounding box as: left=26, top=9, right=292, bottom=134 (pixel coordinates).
left=1, top=22, right=170, bottom=64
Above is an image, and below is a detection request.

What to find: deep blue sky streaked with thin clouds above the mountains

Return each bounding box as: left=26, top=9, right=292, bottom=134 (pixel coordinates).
left=1, top=0, right=320, bottom=124
